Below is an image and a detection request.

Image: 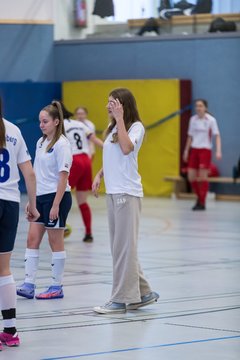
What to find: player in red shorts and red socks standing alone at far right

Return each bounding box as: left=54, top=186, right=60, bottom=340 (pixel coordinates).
left=183, top=99, right=222, bottom=210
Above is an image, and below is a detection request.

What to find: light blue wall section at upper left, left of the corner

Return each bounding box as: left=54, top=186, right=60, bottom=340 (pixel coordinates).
left=0, top=24, right=55, bottom=81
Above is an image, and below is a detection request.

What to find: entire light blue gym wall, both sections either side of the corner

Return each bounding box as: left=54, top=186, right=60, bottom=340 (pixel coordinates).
left=0, top=23, right=240, bottom=192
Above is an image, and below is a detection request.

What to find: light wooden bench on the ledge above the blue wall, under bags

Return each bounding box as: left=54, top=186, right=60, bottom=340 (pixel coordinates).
left=128, top=13, right=240, bottom=29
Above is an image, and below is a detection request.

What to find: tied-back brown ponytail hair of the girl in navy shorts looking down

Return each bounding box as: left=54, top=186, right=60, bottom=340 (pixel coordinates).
left=42, top=101, right=65, bottom=152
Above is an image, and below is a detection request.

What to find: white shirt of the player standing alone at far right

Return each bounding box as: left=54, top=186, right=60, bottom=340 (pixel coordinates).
left=188, top=114, right=219, bottom=149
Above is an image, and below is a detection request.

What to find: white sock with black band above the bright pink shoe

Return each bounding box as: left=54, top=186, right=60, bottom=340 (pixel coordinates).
left=0, top=275, right=16, bottom=328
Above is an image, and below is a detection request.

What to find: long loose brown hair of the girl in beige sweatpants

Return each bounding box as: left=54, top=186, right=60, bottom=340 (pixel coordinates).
left=104, top=88, right=142, bottom=143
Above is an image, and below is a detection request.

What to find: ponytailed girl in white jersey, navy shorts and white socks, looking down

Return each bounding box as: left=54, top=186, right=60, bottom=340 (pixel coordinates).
left=17, top=101, right=72, bottom=300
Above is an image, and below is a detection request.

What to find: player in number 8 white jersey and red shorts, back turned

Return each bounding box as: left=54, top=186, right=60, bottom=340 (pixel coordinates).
left=61, top=102, right=103, bottom=243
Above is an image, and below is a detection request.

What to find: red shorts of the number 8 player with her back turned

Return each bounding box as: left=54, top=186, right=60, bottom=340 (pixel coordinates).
left=69, top=154, right=92, bottom=191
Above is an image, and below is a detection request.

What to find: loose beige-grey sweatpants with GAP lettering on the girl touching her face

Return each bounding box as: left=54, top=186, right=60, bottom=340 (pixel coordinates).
left=107, top=194, right=151, bottom=304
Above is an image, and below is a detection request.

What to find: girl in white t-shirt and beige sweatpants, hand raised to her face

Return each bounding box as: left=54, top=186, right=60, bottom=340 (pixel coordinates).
left=93, top=89, right=159, bottom=314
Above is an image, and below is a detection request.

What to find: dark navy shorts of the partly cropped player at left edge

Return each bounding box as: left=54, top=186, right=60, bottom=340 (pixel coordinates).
left=0, top=200, right=19, bottom=253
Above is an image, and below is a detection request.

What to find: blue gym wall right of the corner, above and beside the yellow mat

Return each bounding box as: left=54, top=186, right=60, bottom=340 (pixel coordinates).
left=55, top=33, right=240, bottom=180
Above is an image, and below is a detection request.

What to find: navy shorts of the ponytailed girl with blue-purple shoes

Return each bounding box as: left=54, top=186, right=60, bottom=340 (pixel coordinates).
left=36, top=191, right=72, bottom=229
